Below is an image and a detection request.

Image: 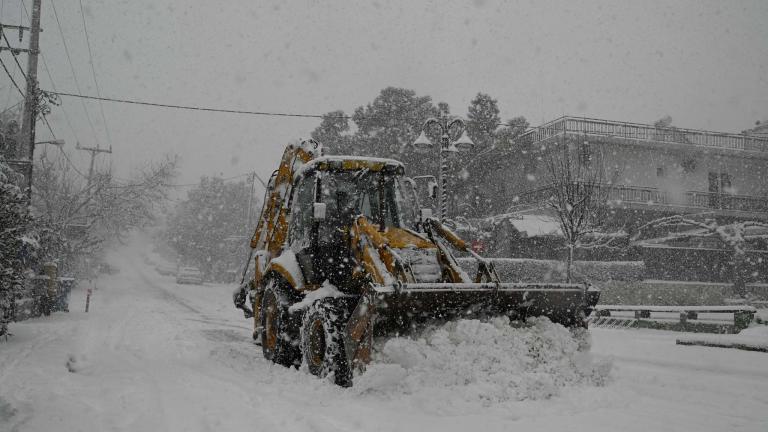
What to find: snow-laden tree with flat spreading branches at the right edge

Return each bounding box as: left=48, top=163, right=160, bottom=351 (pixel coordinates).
left=632, top=215, right=768, bottom=297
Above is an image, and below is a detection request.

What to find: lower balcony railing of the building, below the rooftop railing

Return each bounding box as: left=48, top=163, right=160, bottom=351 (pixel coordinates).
left=519, top=185, right=768, bottom=213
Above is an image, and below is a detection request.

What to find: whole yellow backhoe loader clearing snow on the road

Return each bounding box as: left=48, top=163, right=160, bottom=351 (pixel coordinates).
left=234, top=140, right=600, bottom=386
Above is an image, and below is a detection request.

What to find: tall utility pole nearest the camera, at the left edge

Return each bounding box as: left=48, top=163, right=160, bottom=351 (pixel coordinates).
left=19, top=0, right=42, bottom=203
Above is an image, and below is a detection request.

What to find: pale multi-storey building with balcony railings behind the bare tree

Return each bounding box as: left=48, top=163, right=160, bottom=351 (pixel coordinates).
left=507, top=116, right=768, bottom=222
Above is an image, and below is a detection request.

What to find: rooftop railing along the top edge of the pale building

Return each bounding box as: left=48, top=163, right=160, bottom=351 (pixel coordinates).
left=520, top=117, right=768, bottom=152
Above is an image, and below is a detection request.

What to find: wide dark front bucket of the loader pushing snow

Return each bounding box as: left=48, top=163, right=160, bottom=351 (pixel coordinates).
left=374, top=283, right=600, bottom=334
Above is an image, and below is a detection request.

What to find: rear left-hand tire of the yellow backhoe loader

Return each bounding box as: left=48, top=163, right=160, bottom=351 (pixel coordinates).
left=261, top=279, right=301, bottom=367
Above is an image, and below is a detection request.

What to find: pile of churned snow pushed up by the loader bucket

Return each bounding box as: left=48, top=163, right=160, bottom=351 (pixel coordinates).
left=355, top=317, right=611, bottom=406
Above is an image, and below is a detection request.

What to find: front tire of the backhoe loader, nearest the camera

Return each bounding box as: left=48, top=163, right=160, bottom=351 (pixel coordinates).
left=301, top=298, right=352, bottom=387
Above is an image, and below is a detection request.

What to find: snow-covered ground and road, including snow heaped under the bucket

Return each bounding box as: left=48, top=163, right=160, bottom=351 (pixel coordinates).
left=0, top=238, right=768, bottom=432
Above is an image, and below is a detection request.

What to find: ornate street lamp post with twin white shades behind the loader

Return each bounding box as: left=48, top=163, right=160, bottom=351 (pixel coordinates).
left=413, top=117, right=475, bottom=223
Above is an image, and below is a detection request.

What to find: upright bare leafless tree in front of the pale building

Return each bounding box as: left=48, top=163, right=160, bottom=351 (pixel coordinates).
left=543, top=143, right=626, bottom=282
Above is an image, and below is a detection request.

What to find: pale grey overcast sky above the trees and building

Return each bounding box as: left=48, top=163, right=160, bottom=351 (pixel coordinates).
left=0, top=0, right=768, bottom=186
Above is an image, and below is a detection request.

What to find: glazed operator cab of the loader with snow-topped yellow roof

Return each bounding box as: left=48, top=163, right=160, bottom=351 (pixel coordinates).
left=288, top=157, right=415, bottom=286
